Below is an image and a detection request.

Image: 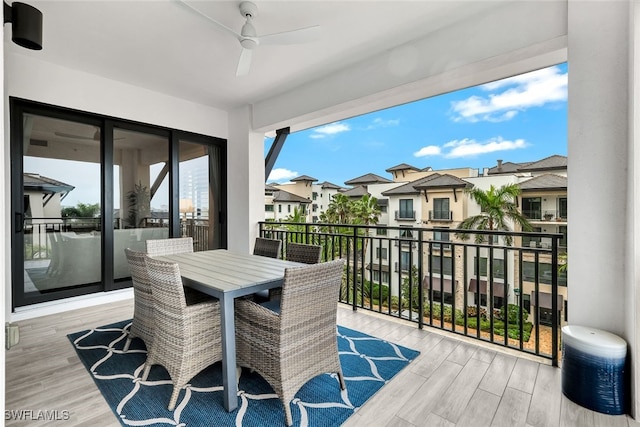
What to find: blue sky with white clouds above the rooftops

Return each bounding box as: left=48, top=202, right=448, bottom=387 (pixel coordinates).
left=264, top=63, right=567, bottom=186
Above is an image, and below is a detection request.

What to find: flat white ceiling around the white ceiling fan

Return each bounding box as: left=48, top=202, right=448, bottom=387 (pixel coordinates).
left=5, top=0, right=501, bottom=110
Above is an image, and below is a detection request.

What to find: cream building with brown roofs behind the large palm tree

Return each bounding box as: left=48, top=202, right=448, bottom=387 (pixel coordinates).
left=282, top=155, right=568, bottom=330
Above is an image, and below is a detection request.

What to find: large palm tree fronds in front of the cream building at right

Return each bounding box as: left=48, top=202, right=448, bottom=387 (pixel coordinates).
left=456, top=184, right=533, bottom=246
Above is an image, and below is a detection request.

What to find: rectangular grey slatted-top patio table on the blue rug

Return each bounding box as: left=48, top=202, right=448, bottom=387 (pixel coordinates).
left=154, top=249, right=304, bottom=412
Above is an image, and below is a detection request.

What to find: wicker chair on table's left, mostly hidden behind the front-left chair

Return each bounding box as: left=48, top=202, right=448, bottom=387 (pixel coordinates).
left=124, top=248, right=154, bottom=351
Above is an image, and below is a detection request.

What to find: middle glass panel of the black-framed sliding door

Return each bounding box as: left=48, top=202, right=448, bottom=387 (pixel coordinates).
left=113, top=128, right=170, bottom=281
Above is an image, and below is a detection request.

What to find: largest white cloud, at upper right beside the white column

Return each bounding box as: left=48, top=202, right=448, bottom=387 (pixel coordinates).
left=451, top=67, right=567, bottom=122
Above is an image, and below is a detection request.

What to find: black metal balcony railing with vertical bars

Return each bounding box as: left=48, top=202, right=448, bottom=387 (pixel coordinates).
left=259, top=222, right=566, bottom=365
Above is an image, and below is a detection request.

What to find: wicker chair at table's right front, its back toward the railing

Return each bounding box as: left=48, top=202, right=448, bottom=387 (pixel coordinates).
left=235, top=260, right=346, bottom=426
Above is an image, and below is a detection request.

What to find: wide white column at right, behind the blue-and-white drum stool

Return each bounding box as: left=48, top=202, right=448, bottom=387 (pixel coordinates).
left=568, top=0, right=640, bottom=414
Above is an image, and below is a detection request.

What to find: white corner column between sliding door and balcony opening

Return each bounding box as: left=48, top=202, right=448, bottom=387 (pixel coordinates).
left=227, top=106, right=265, bottom=252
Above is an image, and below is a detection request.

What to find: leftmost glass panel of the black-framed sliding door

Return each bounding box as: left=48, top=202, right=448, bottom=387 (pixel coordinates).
left=22, top=114, right=102, bottom=298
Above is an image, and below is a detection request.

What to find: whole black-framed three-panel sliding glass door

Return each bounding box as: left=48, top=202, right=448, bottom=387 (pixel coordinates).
left=11, top=99, right=226, bottom=308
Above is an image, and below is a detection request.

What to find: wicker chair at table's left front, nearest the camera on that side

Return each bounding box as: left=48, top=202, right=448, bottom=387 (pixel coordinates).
left=142, top=256, right=222, bottom=411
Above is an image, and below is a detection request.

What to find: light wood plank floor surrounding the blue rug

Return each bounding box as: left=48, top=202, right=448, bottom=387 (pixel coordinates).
left=5, top=301, right=640, bottom=427
